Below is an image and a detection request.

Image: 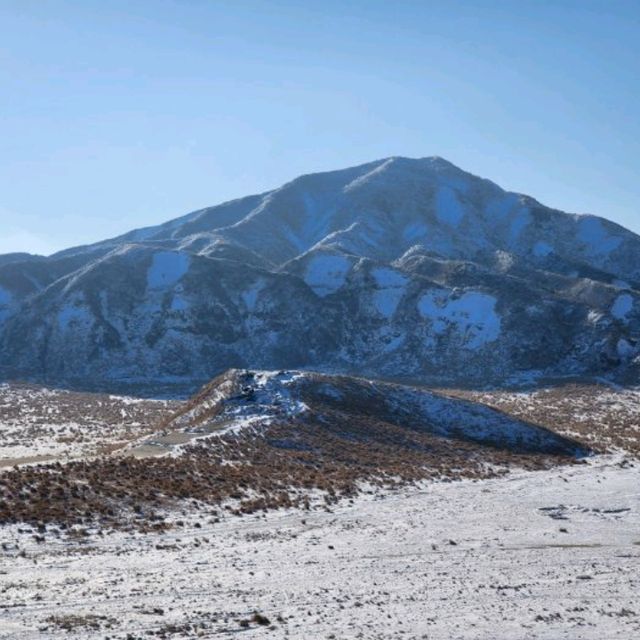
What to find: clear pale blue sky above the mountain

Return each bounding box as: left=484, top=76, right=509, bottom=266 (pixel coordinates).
left=0, top=0, right=640, bottom=253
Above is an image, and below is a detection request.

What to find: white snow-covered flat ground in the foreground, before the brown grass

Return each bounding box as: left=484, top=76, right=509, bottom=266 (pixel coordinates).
left=0, top=454, right=640, bottom=640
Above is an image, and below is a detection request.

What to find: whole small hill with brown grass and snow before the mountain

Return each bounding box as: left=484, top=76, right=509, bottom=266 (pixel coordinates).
left=0, top=370, right=588, bottom=530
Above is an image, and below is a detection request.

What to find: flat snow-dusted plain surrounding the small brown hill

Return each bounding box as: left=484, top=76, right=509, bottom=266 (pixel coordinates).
left=0, top=376, right=640, bottom=640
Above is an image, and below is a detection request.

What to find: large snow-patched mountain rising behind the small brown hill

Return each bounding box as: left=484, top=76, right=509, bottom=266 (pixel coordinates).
left=0, top=157, right=640, bottom=389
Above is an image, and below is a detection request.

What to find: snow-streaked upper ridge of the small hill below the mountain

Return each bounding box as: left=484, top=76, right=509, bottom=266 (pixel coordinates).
left=134, top=369, right=589, bottom=457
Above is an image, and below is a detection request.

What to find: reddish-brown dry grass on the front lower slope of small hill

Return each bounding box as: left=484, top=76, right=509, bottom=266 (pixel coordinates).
left=0, top=415, right=573, bottom=531
